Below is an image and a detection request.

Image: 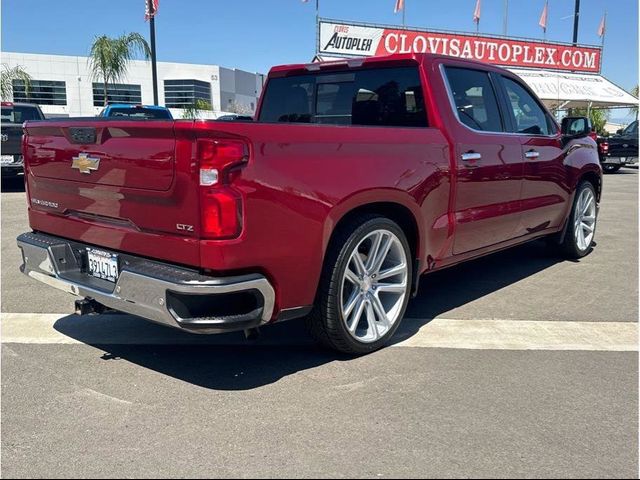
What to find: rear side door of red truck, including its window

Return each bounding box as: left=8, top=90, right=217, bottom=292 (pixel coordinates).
left=444, top=66, right=523, bottom=255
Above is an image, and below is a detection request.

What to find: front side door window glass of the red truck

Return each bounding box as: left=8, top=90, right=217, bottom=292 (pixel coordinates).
left=503, top=77, right=556, bottom=135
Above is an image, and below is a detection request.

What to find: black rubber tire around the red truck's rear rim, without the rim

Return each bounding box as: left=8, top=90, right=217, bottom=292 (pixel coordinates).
left=306, top=214, right=413, bottom=355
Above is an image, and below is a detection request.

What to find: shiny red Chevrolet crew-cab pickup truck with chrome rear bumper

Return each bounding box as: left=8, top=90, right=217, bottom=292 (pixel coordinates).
left=18, top=55, right=602, bottom=354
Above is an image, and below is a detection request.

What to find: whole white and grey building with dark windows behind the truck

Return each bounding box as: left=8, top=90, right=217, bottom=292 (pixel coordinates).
left=1, top=52, right=265, bottom=118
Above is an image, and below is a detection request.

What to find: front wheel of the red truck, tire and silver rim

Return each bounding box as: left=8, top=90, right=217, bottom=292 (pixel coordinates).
left=561, top=181, right=598, bottom=258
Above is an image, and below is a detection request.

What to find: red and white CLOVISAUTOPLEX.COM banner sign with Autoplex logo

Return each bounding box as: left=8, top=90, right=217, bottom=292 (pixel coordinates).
left=318, top=20, right=602, bottom=73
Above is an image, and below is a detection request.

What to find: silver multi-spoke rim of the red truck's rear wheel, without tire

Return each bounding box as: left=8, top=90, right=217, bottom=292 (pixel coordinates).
left=340, top=230, right=409, bottom=343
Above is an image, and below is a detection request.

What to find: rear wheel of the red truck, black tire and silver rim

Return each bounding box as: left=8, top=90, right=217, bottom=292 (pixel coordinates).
left=307, top=215, right=412, bottom=355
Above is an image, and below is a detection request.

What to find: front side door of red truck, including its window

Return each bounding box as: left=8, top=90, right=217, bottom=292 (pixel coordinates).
left=501, top=75, right=569, bottom=236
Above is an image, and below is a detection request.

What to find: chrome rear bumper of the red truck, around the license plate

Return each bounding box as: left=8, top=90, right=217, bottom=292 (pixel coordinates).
left=17, top=233, right=275, bottom=333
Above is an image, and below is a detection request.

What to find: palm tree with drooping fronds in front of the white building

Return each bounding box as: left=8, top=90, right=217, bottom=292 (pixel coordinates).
left=89, top=33, right=151, bottom=106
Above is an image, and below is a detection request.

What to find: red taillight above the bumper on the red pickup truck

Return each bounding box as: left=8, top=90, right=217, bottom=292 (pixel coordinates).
left=196, top=139, right=249, bottom=239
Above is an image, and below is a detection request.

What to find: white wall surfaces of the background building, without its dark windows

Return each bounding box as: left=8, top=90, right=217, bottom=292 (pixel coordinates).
left=0, top=52, right=262, bottom=118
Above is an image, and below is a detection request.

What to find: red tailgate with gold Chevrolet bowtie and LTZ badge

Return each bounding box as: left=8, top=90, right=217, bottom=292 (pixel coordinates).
left=23, top=119, right=200, bottom=266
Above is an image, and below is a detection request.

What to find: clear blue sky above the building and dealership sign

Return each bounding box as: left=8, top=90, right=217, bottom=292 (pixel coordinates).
left=1, top=0, right=638, bottom=116
